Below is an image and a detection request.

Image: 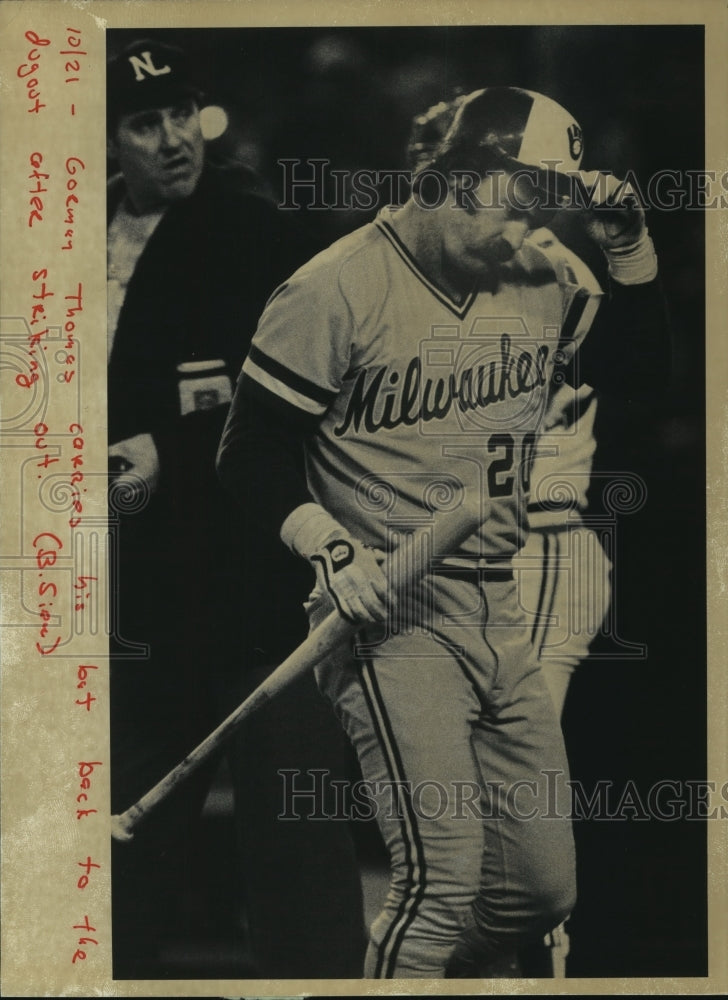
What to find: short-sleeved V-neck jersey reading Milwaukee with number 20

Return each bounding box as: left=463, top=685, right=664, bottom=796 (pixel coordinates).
left=243, top=209, right=597, bottom=558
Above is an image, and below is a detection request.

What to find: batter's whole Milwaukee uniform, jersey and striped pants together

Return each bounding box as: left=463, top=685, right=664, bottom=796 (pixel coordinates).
left=236, top=210, right=596, bottom=977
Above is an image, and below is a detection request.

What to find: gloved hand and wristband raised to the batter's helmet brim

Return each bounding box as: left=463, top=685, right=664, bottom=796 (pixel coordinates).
left=581, top=170, right=657, bottom=285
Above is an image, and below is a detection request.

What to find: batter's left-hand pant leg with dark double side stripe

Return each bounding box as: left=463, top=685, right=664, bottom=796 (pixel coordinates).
left=314, top=588, right=494, bottom=978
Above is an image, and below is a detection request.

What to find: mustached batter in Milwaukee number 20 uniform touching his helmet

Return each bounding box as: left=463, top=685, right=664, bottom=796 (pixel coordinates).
left=218, top=88, right=667, bottom=978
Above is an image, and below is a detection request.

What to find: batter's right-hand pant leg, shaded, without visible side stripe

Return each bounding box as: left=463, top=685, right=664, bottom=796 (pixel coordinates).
left=452, top=582, right=575, bottom=975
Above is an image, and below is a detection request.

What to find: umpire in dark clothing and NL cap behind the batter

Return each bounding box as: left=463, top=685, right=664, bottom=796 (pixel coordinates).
left=108, top=40, right=365, bottom=978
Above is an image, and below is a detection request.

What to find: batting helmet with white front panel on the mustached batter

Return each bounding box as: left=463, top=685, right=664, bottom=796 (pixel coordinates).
left=420, top=87, right=583, bottom=201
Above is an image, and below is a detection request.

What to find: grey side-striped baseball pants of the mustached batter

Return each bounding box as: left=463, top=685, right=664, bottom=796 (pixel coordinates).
left=309, top=572, right=575, bottom=978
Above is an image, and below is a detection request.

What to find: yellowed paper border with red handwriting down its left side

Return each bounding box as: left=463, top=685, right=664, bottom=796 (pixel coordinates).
left=0, top=0, right=728, bottom=996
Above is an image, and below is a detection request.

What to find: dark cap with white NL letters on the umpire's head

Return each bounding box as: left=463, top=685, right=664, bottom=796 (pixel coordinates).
left=106, top=39, right=202, bottom=130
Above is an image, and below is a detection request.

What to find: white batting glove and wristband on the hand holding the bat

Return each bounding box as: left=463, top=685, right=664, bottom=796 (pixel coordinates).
left=281, top=503, right=394, bottom=623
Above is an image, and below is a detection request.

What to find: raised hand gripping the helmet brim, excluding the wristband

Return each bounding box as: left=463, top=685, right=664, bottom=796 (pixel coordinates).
left=579, top=170, right=646, bottom=252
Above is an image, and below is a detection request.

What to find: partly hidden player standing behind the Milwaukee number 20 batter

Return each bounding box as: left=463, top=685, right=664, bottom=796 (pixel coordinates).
left=407, top=103, right=611, bottom=976
